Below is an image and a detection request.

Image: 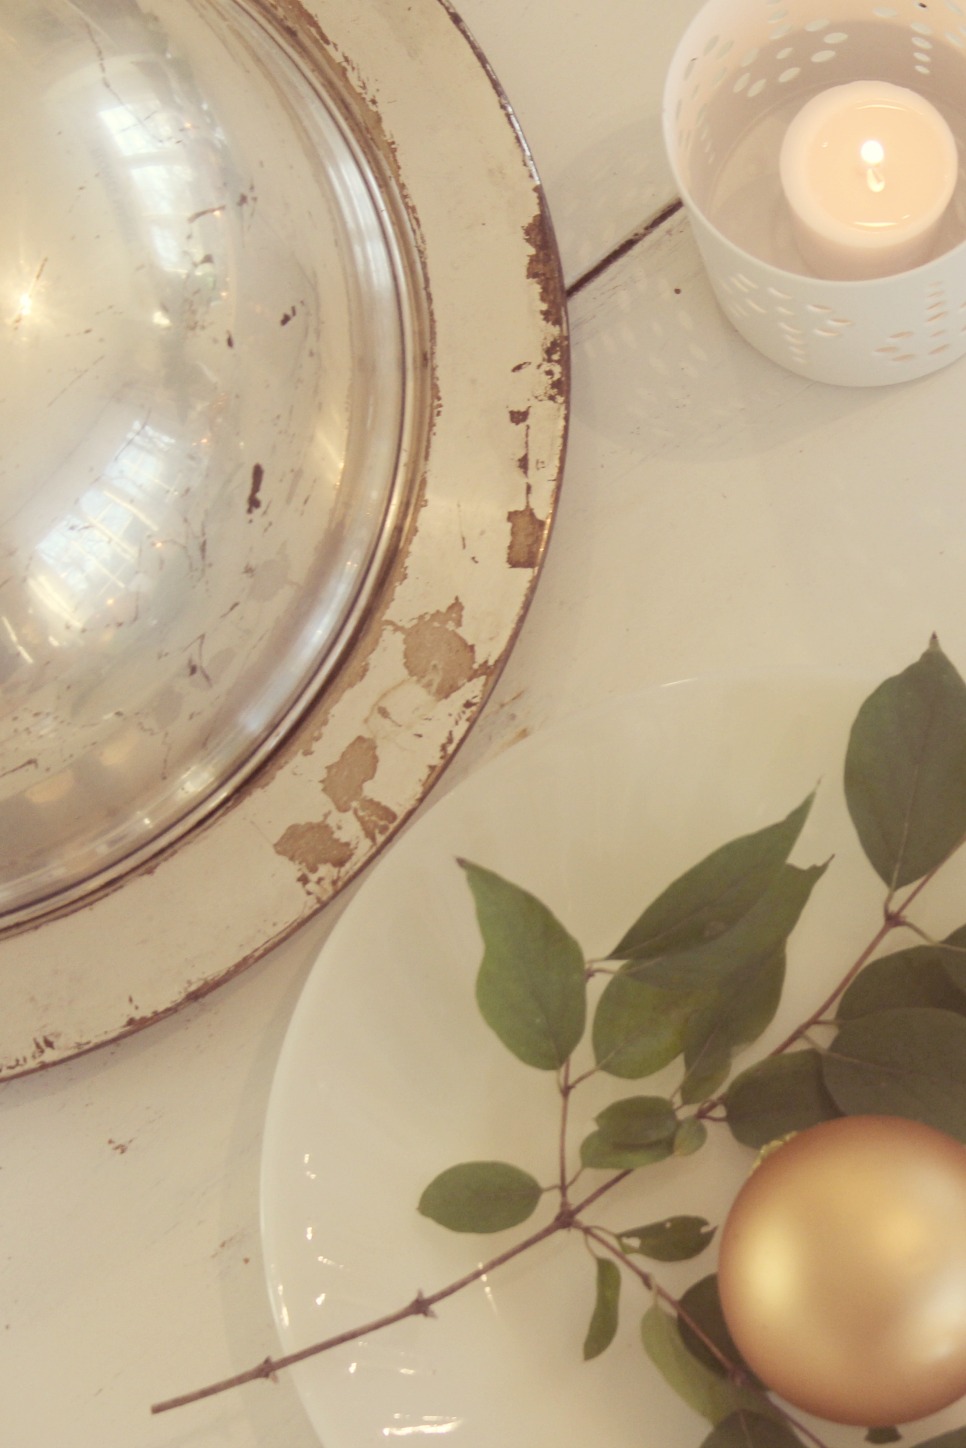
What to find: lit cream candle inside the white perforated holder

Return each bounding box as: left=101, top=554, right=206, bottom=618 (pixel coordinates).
left=779, top=81, right=959, bottom=279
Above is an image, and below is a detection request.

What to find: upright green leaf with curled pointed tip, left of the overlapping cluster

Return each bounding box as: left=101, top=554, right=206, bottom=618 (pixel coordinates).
left=459, top=860, right=587, bottom=1070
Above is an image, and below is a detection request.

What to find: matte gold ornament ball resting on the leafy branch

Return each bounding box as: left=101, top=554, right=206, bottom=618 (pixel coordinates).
left=718, top=1116, right=966, bottom=1428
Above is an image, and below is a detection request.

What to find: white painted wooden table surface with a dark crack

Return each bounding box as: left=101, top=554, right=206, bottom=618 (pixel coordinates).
left=0, top=0, right=966, bottom=1448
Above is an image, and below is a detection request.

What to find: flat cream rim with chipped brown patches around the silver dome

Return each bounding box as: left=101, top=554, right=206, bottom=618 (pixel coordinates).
left=0, top=0, right=568, bottom=1077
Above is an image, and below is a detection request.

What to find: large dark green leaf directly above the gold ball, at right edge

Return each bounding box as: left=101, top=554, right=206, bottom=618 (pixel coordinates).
left=821, top=1006, right=966, bottom=1141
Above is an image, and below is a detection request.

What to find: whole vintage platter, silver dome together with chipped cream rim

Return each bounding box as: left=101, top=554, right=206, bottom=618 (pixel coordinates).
left=0, top=0, right=568, bottom=1076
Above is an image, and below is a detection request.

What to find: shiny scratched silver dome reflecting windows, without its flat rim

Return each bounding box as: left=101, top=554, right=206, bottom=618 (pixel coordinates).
left=0, top=0, right=414, bottom=924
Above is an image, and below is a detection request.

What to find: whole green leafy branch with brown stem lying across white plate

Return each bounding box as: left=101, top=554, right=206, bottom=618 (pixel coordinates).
left=152, top=639, right=966, bottom=1448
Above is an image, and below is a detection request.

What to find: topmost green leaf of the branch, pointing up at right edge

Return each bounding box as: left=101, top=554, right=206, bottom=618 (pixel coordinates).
left=844, top=639, right=966, bottom=891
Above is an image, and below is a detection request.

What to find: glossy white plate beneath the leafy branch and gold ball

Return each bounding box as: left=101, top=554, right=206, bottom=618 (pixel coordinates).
left=262, top=681, right=962, bottom=1448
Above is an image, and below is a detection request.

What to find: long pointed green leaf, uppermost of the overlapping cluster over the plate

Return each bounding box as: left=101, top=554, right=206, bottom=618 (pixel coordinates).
left=611, top=794, right=815, bottom=960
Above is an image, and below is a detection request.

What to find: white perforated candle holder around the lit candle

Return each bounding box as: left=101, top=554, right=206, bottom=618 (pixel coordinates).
left=663, top=0, right=966, bottom=387
